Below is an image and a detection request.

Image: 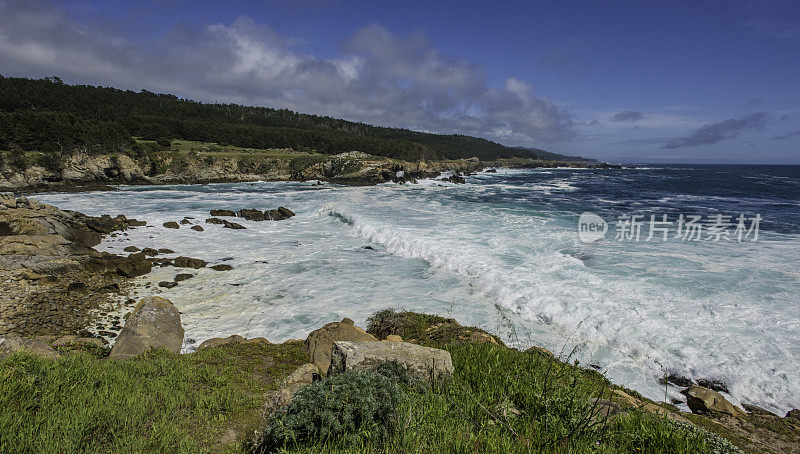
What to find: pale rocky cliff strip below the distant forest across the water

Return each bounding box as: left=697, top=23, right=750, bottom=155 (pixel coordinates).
left=0, top=152, right=619, bottom=193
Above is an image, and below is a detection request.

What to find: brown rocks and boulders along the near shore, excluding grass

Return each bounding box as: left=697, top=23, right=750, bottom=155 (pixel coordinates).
left=0, top=195, right=800, bottom=452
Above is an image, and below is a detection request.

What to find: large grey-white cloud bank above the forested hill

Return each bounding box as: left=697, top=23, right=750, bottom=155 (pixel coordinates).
left=0, top=0, right=574, bottom=145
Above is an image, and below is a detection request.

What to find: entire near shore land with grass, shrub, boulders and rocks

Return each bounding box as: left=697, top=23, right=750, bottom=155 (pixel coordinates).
left=0, top=195, right=800, bottom=453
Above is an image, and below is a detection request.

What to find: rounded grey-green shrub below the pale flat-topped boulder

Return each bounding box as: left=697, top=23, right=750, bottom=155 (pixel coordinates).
left=254, top=371, right=401, bottom=453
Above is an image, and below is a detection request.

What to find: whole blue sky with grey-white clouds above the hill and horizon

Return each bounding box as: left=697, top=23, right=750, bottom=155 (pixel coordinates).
left=0, top=0, right=800, bottom=164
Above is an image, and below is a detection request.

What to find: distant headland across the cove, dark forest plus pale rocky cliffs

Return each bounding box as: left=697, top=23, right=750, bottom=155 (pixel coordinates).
left=0, top=76, right=619, bottom=193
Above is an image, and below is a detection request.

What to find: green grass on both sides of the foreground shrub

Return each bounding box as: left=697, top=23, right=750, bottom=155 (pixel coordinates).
left=0, top=311, right=744, bottom=453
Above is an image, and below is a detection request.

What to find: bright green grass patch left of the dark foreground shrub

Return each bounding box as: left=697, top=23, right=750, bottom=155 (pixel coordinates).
left=0, top=343, right=308, bottom=453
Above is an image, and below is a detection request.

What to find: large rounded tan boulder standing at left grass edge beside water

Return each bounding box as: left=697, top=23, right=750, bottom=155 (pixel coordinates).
left=110, top=296, right=183, bottom=359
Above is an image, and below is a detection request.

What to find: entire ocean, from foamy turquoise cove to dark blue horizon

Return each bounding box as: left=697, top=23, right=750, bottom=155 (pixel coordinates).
left=37, top=165, right=800, bottom=414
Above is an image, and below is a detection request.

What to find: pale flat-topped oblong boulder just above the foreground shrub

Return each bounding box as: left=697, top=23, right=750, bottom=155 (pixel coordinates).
left=328, top=341, right=454, bottom=381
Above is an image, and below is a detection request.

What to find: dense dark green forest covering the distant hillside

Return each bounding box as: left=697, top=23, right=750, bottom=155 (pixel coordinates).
left=0, top=76, right=592, bottom=160
